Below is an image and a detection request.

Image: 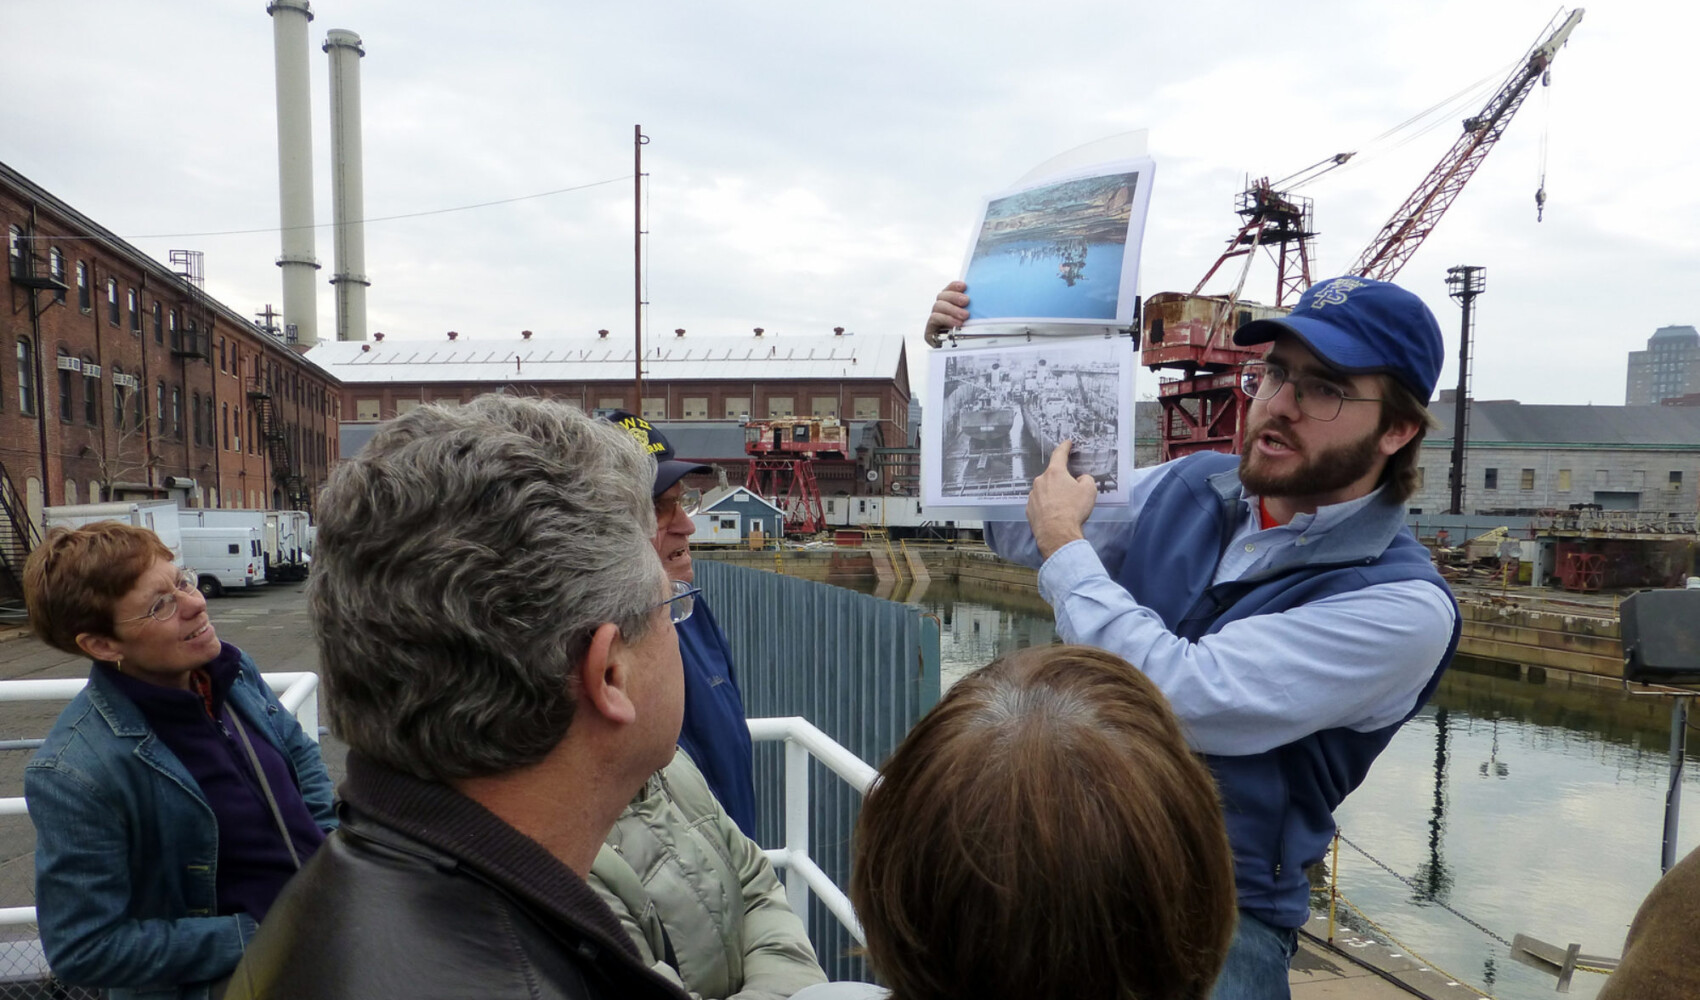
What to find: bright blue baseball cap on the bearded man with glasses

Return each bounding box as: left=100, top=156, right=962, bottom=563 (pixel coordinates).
left=1234, top=276, right=1445, bottom=403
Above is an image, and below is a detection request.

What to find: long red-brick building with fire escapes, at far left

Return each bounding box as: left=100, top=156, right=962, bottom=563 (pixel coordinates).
left=0, top=163, right=342, bottom=527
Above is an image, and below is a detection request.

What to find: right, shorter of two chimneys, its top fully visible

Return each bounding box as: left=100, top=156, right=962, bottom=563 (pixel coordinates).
left=325, top=27, right=372, bottom=340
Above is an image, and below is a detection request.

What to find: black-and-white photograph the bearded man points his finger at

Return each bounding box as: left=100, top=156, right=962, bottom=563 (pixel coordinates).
left=940, top=340, right=1131, bottom=500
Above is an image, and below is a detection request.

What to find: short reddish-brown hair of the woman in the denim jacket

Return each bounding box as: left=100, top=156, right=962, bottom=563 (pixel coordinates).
left=24, top=520, right=172, bottom=655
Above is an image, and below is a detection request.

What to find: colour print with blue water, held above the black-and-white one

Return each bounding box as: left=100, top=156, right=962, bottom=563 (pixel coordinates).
left=962, top=160, right=1153, bottom=327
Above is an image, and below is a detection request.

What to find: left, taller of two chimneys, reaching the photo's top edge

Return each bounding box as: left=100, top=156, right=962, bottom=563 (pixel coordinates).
left=265, top=0, right=318, bottom=347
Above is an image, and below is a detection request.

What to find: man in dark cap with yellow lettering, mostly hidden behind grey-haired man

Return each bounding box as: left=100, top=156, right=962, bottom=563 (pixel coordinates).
left=609, top=410, right=755, bottom=837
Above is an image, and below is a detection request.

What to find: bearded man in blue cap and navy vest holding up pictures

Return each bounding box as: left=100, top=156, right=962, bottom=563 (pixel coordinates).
left=928, top=277, right=1459, bottom=1000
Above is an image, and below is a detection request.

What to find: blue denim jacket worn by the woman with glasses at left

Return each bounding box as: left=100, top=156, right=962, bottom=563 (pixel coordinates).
left=24, top=642, right=337, bottom=1000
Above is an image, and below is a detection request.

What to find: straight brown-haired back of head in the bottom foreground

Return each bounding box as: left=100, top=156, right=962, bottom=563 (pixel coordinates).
left=850, top=646, right=1234, bottom=1000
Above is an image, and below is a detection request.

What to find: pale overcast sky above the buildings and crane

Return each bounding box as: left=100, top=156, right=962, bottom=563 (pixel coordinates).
left=0, top=0, right=1700, bottom=403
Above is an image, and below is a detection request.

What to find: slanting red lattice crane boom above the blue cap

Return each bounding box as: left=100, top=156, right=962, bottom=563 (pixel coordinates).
left=1350, top=7, right=1583, bottom=281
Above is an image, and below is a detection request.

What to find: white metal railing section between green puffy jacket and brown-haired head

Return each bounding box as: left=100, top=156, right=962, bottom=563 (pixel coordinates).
left=748, top=716, right=879, bottom=944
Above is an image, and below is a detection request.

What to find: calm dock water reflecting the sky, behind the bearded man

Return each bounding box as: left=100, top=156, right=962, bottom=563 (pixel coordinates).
left=842, top=580, right=1700, bottom=1000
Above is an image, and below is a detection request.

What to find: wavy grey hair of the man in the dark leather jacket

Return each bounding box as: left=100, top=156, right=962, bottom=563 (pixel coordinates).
left=308, top=395, right=661, bottom=781
